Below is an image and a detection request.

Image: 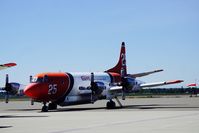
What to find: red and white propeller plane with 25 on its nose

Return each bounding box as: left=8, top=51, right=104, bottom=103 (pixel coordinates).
left=3, top=42, right=183, bottom=112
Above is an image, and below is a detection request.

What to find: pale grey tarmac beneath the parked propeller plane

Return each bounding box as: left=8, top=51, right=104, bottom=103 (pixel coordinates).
left=0, top=96, right=199, bottom=133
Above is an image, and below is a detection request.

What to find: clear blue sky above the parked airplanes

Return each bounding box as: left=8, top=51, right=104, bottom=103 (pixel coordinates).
left=0, top=0, right=199, bottom=86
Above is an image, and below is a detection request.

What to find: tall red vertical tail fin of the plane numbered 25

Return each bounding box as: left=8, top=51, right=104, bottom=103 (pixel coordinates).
left=106, top=42, right=127, bottom=77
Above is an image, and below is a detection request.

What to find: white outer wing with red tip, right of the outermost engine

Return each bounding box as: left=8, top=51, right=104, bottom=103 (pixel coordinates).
left=140, top=80, right=184, bottom=89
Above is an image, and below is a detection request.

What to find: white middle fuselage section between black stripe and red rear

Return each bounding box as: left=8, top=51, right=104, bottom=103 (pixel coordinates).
left=60, top=72, right=111, bottom=106
